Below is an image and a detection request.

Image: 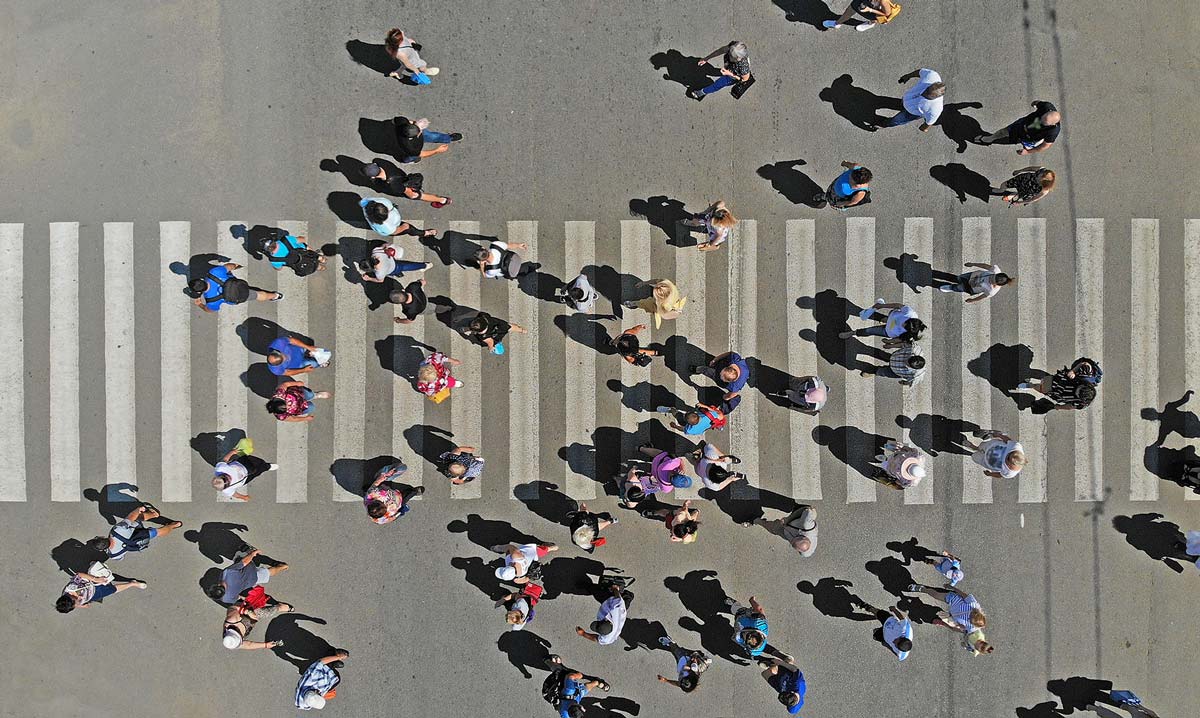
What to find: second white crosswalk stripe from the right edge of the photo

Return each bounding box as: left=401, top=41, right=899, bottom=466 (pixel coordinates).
left=1128, top=219, right=1156, bottom=501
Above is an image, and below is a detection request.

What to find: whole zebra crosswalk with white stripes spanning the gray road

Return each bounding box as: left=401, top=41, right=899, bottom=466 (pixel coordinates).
left=0, top=216, right=1200, bottom=505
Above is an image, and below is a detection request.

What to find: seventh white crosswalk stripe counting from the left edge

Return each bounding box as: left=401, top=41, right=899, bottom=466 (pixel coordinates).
left=333, top=222, right=364, bottom=502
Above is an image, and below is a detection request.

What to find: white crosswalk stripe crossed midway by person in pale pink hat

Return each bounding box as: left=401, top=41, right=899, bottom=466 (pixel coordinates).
left=784, top=220, right=821, bottom=501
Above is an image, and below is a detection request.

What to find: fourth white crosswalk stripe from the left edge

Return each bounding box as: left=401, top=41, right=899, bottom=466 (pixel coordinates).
left=158, top=222, right=199, bottom=503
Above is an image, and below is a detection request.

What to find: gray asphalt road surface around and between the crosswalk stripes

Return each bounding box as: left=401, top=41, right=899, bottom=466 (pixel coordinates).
left=0, top=0, right=1200, bottom=718
